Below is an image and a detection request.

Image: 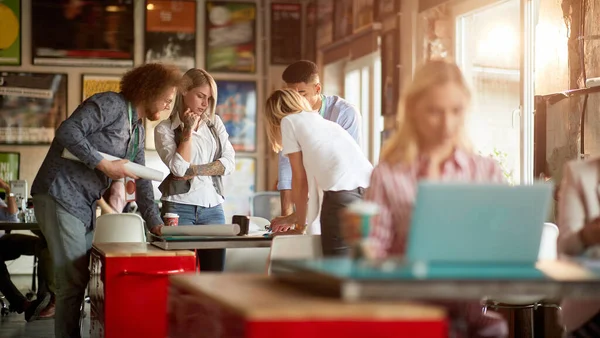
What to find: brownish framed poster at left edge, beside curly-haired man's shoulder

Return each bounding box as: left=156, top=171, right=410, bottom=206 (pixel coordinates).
left=0, top=72, right=67, bottom=144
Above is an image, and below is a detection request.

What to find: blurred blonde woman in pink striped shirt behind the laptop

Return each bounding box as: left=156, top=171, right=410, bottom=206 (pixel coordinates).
left=356, top=61, right=508, bottom=337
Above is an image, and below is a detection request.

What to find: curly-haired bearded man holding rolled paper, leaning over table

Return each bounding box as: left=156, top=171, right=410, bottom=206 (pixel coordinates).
left=31, top=64, right=181, bottom=338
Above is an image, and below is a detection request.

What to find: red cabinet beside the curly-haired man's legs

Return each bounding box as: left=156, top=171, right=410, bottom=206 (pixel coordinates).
left=89, top=243, right=195, bottom=338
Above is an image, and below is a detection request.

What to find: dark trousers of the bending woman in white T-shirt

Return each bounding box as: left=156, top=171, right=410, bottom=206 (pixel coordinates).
left=321, top=188, right=365, bottom=257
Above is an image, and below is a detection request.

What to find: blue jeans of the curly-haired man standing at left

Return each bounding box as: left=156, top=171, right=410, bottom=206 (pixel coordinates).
left=33, top=195, right=94, bottom=338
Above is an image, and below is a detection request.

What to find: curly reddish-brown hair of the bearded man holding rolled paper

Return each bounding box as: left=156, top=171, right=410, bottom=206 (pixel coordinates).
left=121, top=63, right=181, bottom=105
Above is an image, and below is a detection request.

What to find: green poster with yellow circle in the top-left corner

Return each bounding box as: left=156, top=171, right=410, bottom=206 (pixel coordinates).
left=0, top=0, right=21, bottom=66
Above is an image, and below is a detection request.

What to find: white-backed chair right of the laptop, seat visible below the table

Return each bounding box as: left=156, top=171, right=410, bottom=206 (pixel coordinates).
left=483, top=223, right=560, bottom=334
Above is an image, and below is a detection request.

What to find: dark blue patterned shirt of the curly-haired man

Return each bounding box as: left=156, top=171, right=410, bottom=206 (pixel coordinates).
left=31, top=92, right=163, bottom=228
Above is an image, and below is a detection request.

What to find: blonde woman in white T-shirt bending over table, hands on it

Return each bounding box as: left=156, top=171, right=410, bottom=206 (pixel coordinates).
left=265, top=89, right=373, bottom=256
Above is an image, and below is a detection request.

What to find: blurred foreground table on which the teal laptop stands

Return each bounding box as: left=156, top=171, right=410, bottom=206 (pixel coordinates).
left=271, top=259, right=600, bottom=301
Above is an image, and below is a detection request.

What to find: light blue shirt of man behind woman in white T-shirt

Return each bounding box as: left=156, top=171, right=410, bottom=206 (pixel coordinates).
left=277, top=95, right=361, bottom=190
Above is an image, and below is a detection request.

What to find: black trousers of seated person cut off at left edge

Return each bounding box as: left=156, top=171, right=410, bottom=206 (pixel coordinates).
left=0, top=234, right=54, bottom=312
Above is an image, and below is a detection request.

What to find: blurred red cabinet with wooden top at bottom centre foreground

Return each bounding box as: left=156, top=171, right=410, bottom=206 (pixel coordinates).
left=168, top=273, right=448, bottom=338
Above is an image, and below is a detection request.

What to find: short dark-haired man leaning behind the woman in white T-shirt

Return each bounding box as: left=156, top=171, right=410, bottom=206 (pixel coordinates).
left=271, top=60, right=361, bottom=231
